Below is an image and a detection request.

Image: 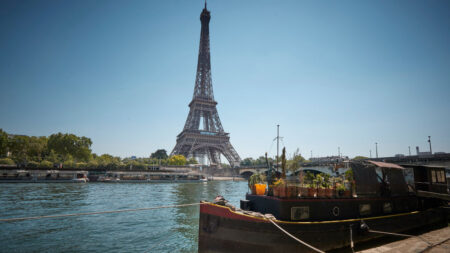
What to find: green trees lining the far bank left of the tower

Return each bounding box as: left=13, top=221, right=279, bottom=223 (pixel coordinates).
left=0, top=129, right=197, bottom=169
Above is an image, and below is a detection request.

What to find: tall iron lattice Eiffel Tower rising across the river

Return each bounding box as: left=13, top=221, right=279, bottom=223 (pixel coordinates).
left=171, top=2, right=241, bottom=167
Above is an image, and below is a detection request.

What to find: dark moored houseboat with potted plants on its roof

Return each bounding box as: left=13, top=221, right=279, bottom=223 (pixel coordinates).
left=198, top=161, right=449, bottom=252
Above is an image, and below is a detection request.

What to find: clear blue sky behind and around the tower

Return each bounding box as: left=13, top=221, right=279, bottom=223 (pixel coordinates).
left=0, top=0, right=450, bottom=158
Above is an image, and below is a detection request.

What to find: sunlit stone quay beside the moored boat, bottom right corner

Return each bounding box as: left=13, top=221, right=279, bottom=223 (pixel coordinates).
left=359, top=227, right=450, bottom=253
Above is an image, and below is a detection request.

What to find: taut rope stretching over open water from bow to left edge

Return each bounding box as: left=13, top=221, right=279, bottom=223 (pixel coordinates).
left=0, top=202, right=204, bottom=222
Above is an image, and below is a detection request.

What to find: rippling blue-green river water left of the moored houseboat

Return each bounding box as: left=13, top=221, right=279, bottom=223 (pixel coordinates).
left=0, top=181, right=247, bottom=252
